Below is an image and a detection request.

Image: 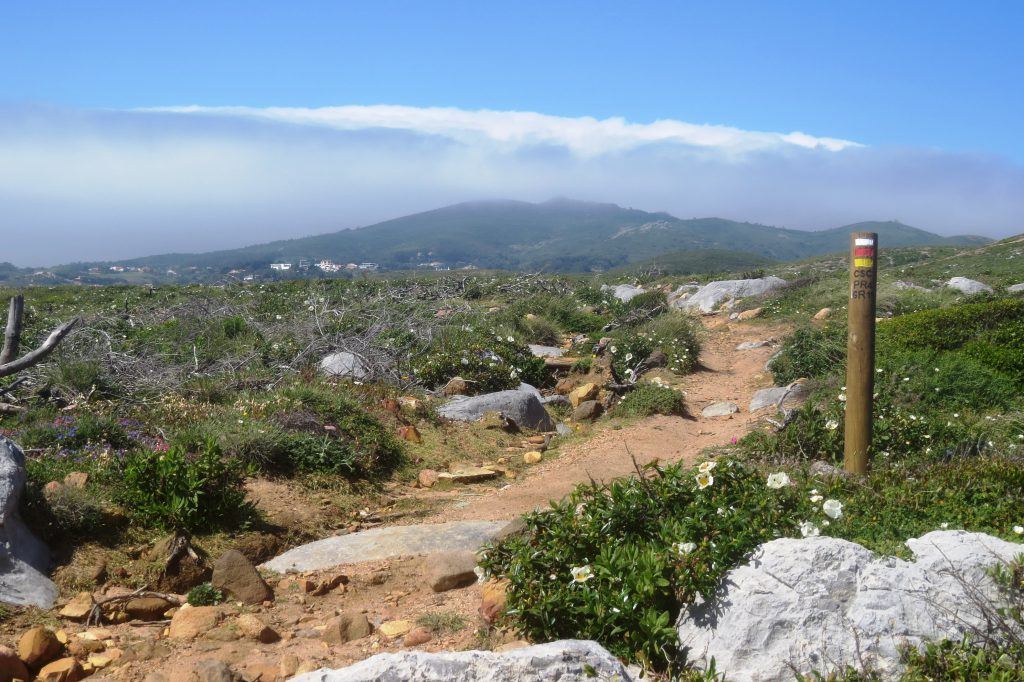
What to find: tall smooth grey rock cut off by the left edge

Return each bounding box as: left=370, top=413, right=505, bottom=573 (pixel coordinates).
left=0, top=436, right=58, bottom=608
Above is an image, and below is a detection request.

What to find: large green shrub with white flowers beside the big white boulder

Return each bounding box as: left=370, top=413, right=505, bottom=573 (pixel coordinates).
left=482, top=460, right=826, bottom=668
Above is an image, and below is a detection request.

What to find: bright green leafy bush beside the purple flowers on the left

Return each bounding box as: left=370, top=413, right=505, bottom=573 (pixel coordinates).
left=119, top=440, right=252, bottom=532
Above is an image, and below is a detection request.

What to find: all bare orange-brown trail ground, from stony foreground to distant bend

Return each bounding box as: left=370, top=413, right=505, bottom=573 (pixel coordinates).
left=0, top=317, right=786, bottom=682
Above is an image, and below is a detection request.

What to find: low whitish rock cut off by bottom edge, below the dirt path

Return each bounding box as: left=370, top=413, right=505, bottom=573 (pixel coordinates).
left=292, top=639, right=633, bottom=682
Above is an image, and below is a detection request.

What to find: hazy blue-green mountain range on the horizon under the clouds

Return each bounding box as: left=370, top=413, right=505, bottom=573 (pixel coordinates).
left=4, top=199, right=989, bottom=283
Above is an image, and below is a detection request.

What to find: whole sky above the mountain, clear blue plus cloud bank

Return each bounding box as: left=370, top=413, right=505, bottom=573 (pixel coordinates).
left=0, top=0, right=1024, bottom=263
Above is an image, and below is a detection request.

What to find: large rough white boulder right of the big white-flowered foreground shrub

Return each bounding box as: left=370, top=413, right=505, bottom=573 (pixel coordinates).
left=677, top=530, right=1024, bottom=682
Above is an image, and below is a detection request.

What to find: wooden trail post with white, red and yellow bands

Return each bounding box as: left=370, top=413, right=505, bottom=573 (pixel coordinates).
left=843, top=232, right=879, bottom=475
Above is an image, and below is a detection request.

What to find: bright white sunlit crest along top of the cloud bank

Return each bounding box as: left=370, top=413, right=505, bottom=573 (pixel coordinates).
left=141, top=104, right=860, bottom=157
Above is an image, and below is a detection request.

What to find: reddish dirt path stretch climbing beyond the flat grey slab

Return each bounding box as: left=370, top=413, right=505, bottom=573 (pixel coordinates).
left=425, top=318, right=787, bottom=522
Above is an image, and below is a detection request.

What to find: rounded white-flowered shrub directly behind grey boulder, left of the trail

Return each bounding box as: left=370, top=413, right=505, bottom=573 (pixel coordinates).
left=413, top=327, right=547, bottom=393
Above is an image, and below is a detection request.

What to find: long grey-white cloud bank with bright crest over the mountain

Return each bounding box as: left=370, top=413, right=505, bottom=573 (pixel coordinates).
left=0, top=105, right=1024, bottom=265
